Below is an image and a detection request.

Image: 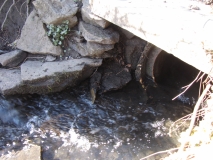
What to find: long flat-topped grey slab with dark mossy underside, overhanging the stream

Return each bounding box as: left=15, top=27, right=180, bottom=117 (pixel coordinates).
left=21, top=58, right=102, bottom=93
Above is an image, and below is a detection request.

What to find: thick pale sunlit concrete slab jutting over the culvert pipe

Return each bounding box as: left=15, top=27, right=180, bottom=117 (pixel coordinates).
left=89, top=0, right=213, bottom=75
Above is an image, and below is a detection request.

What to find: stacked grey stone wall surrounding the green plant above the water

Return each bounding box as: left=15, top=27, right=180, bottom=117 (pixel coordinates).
left=0, top=0, right=138, bottom=97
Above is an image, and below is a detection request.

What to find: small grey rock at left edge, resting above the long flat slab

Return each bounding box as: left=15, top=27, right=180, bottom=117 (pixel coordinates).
left=0, top=50, right=27, bottom=67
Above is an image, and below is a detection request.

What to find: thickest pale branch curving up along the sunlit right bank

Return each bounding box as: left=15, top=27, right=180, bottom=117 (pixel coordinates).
left=178, top=84, right=211, bottom=152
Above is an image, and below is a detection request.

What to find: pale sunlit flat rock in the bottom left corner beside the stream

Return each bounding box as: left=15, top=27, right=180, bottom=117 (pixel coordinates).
left=0, top=145, right=41, bottom=160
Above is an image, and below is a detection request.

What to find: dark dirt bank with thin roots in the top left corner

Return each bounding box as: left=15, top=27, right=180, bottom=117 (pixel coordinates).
left=0, top=0, right=32, bottom=50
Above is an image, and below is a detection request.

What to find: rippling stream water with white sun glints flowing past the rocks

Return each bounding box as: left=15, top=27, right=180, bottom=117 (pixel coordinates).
left=0, top=81, right=196, bottom=160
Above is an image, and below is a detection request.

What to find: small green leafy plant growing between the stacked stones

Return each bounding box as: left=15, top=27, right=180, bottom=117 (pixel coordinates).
left=47, top=20, right=70, bottom=48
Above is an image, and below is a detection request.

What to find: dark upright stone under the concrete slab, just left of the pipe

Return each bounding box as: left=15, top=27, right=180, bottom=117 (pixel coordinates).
left=124, top=37, right=146, bottom=70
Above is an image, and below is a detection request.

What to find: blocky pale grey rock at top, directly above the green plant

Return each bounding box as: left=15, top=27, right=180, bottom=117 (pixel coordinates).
left=33, top=0, right=78, bottom=27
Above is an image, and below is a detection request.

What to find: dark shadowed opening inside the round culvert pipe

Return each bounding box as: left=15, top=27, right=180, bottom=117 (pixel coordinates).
left=153, top=51, right=199, bottom=88
